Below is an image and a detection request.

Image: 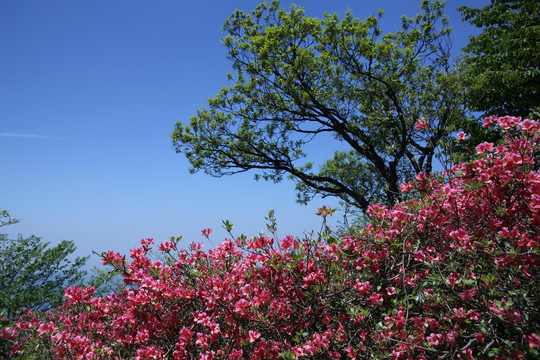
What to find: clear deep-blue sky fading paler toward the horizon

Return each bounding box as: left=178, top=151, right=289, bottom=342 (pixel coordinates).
left=0, top=0, right=487, bottom=263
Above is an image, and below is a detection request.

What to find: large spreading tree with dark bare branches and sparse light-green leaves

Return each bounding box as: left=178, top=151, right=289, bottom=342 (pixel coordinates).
left=172, top=0, right=464, bottom=211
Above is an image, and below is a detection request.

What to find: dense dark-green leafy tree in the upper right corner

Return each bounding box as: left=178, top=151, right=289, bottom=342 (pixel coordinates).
left=459, top=0, right=540, bottom=117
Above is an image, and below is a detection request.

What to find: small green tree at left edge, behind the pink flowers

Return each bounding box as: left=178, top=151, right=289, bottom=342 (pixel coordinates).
left=0, top=212, right=88, bottom=319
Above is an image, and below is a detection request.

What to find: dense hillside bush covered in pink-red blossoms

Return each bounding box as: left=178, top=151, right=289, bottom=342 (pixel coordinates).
left=2, top=117, right=540, bottom=360
